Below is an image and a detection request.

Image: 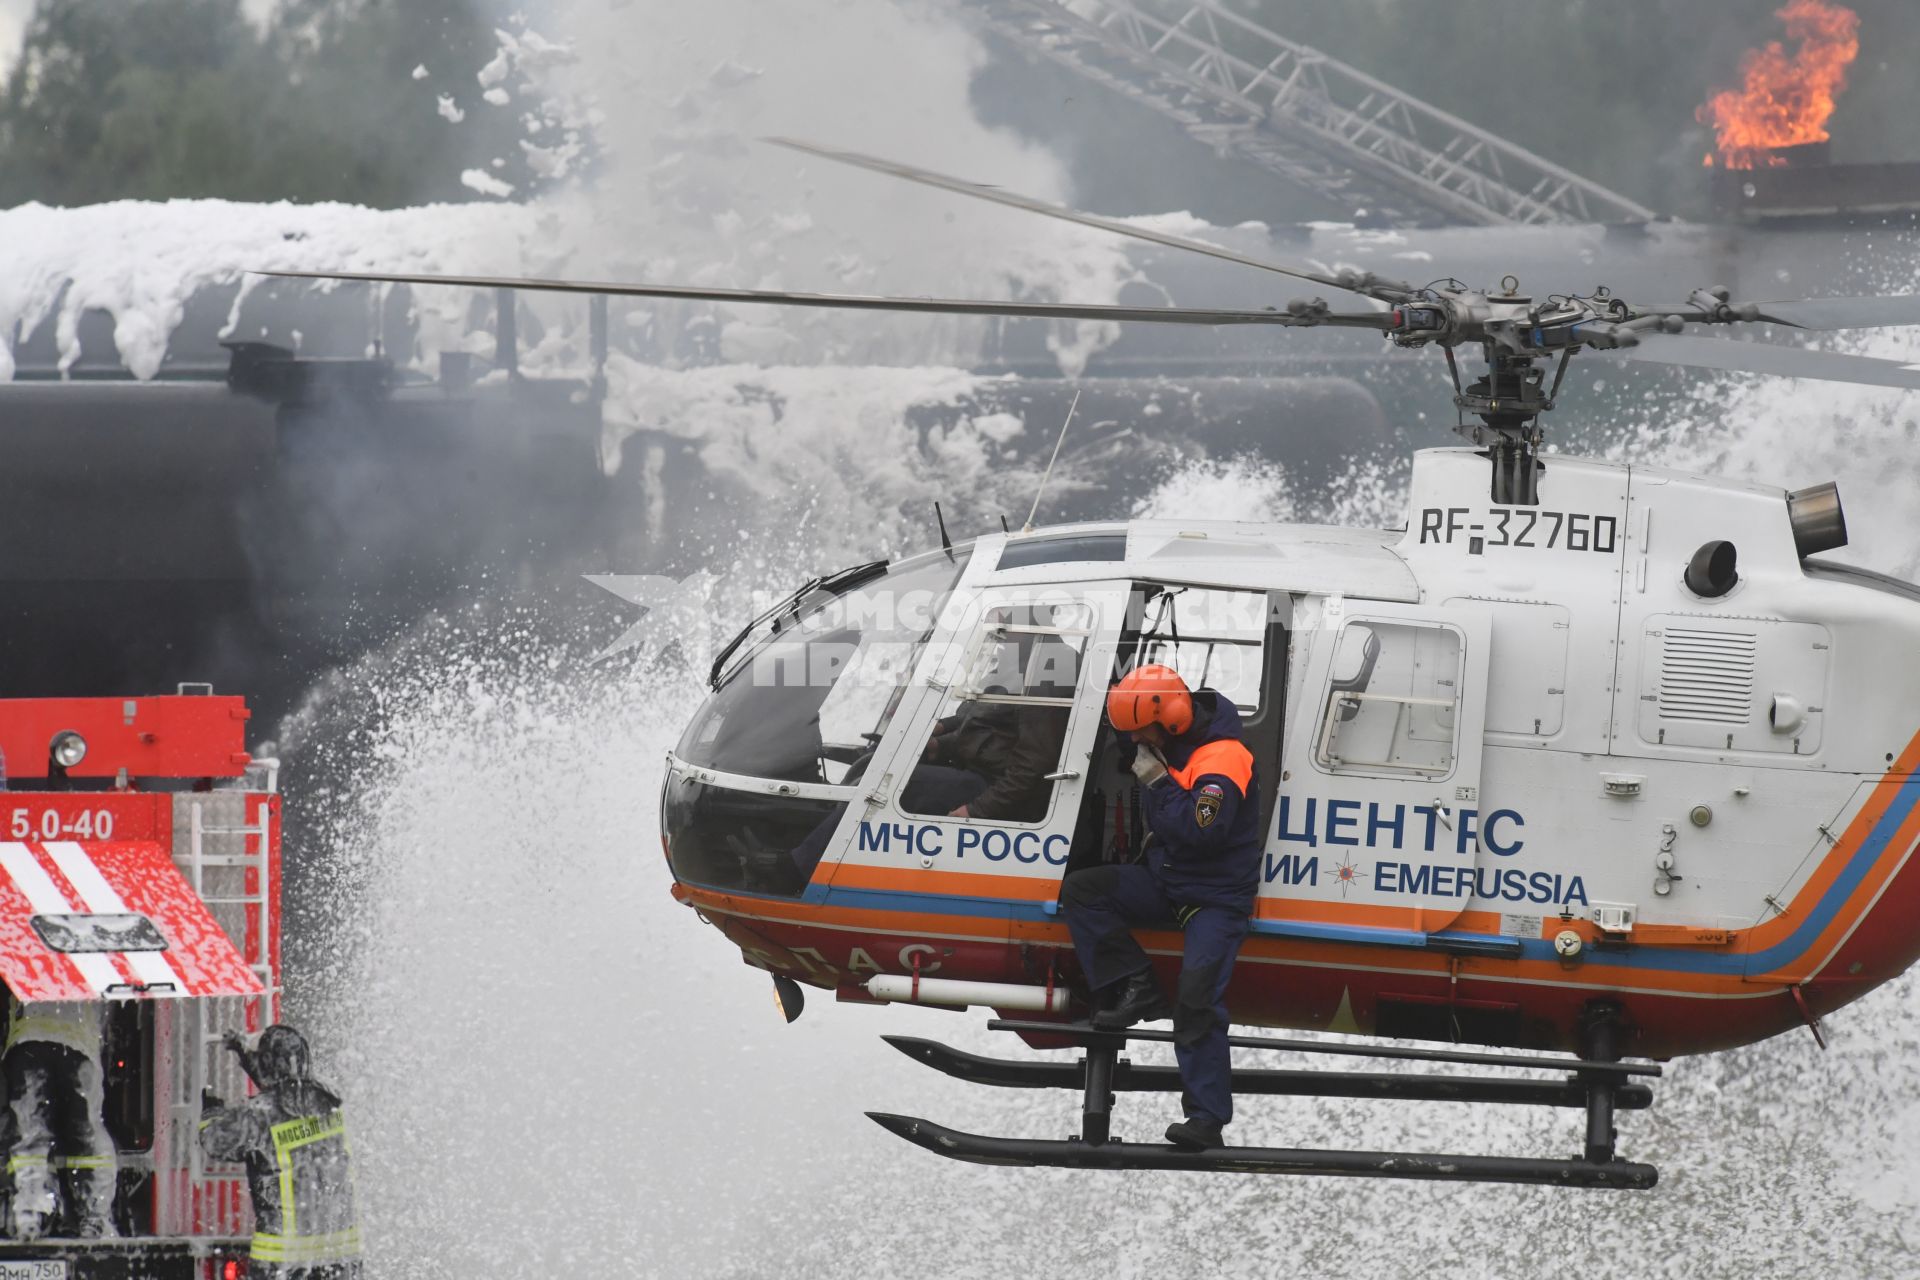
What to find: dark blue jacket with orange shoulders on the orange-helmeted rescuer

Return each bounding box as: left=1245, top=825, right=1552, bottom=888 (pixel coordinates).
left=1142, top=689, right=1260, bottom=913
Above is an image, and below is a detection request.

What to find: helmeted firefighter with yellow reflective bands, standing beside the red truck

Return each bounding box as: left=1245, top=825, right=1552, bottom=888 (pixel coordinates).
left=200, top=1025, right=361, bottom=1280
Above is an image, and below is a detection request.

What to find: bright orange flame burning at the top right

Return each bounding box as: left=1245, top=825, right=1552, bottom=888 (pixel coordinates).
left=1695, top=0, right=1860, bottom=169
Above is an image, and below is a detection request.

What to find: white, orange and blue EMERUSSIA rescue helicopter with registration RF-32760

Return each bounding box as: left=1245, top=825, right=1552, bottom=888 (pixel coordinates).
left=274, top=138, right=1920, bottom=1190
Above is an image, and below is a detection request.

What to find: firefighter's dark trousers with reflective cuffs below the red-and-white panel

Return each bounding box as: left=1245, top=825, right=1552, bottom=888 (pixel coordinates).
left=0, top=996, right=119, bottom=1240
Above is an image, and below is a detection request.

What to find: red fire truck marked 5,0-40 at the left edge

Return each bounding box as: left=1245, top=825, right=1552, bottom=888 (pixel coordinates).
left=0, top=685, right=280, bottom=1280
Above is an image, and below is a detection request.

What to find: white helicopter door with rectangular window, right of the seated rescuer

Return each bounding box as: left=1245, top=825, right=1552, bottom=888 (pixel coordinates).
left=1290, top=599, right=1490, bottom=933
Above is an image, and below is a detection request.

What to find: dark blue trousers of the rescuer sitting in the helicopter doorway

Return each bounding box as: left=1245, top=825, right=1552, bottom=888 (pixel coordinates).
left=1060, top=864, right=1246, bottom=1125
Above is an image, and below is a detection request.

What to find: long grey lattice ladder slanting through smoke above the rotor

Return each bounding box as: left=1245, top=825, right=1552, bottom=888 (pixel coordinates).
left=970, top=0, right=1655, bottom=226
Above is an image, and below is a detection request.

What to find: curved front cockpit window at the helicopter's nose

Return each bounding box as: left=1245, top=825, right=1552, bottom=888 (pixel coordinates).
left=678, top=553, right=966, bottom=787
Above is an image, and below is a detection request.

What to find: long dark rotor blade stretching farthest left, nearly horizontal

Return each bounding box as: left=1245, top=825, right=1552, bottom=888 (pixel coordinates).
left=255, top=271, right=1392, bottom=330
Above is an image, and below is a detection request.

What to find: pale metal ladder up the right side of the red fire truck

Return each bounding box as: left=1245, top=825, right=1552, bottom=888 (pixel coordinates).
left=161, top=760, right=280, bottom=1236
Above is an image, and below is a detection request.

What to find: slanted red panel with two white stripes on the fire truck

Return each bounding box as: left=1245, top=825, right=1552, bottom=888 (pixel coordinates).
left=0, top=841, right=261, bottom=1004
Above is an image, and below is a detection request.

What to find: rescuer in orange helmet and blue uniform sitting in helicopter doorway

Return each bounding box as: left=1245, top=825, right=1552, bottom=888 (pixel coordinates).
left=1060, top=666, right=1260, bottom=1150
